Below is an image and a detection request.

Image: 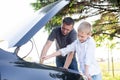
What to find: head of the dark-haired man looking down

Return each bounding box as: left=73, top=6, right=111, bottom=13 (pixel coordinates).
left=61, top=17, right=74, bottom=35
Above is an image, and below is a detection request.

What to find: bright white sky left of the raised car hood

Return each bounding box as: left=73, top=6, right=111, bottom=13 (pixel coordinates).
left=0, top=0, right=35, bottom=39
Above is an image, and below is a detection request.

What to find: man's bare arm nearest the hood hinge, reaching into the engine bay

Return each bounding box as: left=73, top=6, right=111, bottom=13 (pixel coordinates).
left=40, top=40, right=53, bottom=64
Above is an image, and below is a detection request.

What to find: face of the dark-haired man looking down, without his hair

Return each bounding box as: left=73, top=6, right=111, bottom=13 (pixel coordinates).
left=61, top=23, right=73, bottom=35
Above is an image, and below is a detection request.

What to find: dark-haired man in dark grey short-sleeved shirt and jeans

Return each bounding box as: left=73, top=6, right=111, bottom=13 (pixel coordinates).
left=40, top=17, right=78, bottom=71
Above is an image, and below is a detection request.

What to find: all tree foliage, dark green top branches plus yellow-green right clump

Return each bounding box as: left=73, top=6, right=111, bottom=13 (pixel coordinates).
left=31, top=0, right=120, bottom=46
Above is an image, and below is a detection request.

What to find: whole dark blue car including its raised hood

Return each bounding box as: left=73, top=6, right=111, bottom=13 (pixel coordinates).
left=0, top=0, right=85, bottom=80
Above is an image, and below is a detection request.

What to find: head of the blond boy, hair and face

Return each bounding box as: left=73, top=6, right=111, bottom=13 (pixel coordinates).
left=78, top=22, right=92, bottom=42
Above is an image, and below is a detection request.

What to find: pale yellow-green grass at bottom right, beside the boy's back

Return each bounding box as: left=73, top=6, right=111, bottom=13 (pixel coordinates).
left=99, top=62, right=120, bottom=80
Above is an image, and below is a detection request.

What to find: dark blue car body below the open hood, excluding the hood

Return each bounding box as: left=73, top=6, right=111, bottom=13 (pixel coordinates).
left=0, top=49, right=84, bottom=80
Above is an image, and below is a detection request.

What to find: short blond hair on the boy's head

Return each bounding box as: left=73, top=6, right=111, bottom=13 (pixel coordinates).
left=78, top=21, right=92, bottom=34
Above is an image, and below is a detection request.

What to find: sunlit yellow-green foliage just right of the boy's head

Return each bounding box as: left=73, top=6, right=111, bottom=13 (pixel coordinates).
left=93, top=12, right=120, bottom=46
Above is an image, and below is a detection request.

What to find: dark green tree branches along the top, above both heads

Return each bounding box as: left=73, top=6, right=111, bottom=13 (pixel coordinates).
left=31, top=0, right=120, bottom=32
